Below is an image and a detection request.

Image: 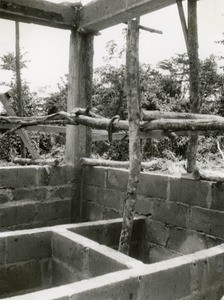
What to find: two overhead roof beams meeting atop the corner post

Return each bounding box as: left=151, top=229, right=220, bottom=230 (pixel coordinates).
left=0, top=0, right=182, bottom=32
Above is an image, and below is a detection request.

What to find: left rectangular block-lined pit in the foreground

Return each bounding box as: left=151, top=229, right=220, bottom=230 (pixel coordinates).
left=0, top=230, right=127, bottom=299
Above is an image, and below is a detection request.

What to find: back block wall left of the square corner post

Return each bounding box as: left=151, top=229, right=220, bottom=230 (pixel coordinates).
left=0, top=166, right=74, bottom=231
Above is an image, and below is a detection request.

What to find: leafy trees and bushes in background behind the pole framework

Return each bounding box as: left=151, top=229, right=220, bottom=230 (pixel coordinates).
left=0, top=40, right=224, bottom=165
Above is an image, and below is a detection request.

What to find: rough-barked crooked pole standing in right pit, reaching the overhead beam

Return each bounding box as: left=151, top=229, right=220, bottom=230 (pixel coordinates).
left=118, top=20, right=142, bottom=254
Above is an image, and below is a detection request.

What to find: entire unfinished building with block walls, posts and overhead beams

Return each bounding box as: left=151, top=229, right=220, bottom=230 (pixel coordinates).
left=0, top=0, right=224, bottom=300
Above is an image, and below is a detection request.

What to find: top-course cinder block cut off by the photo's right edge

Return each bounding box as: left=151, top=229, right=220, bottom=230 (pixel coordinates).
left=210, top=183, right=224, bottom=211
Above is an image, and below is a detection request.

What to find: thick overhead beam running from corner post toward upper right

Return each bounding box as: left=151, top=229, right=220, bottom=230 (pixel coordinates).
left=79, top=0, right=179, bottom=31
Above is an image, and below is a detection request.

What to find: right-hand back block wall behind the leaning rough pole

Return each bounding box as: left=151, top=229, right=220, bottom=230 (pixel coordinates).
left=82, top=167, right=224, bottom=263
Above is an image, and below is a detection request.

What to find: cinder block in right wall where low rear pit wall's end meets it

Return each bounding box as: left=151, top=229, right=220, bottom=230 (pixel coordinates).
left=143, top=218, right=169, bottom=246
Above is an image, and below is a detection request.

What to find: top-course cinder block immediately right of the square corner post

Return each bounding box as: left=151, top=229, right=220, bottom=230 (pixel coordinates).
left=83, top=167, right=107, bottom=187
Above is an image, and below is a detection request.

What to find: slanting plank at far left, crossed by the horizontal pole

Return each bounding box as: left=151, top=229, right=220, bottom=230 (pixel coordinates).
left=0, top=94, right=39, bottom=159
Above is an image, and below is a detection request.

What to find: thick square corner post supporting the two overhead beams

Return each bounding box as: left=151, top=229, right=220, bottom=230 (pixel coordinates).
left=66, top=31, right=93, bottom=221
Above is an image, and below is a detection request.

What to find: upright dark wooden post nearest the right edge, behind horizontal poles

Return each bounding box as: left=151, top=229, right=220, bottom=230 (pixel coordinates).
left=187, top=0, right=200, bottom=173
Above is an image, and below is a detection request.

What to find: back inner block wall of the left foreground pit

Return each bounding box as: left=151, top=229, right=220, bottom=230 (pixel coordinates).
left=0, top=231, right=52, bottom=298
